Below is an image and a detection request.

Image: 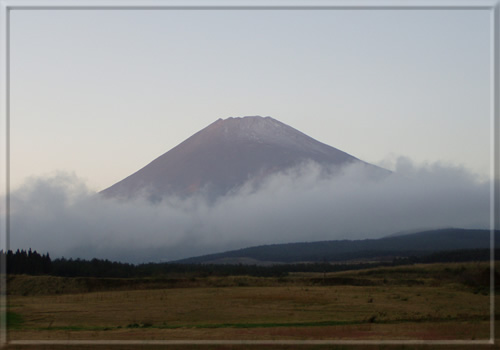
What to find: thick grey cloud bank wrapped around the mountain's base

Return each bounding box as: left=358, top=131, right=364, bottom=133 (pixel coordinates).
left=10, top=158, right=490, bottom=263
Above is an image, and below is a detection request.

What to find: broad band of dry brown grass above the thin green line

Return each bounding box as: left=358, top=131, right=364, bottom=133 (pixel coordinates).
left=9, top=286, right=489, bottom=329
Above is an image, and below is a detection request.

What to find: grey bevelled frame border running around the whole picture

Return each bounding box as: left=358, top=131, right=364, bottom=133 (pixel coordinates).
left=0, top=0, right=500, bottom=346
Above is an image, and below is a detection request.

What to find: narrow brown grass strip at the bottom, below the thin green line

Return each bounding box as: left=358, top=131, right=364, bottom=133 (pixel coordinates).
left=6, top=321, right=488, bottom=340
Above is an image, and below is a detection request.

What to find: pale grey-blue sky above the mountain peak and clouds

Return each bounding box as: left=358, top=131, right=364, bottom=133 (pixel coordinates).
left=7, top=6, right=490, bottom=194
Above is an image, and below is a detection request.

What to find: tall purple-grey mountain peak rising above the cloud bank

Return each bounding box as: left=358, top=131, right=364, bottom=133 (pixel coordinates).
left=101, top=116, right=390, bottom=201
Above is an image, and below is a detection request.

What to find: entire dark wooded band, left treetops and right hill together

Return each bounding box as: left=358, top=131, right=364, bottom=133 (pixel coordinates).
left=0, top=229, right=500, bottom=278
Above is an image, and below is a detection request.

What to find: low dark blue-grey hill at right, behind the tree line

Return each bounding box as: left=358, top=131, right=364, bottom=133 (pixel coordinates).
left=178, top=229, right=500, bottom=265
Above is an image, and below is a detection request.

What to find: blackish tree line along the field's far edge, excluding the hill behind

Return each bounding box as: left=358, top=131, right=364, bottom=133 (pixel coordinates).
left=0, top=249, right=500, bottom=278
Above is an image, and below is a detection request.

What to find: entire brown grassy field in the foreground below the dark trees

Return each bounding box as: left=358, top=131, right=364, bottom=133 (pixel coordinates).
left=1, top=263, right=498, bottom=348
